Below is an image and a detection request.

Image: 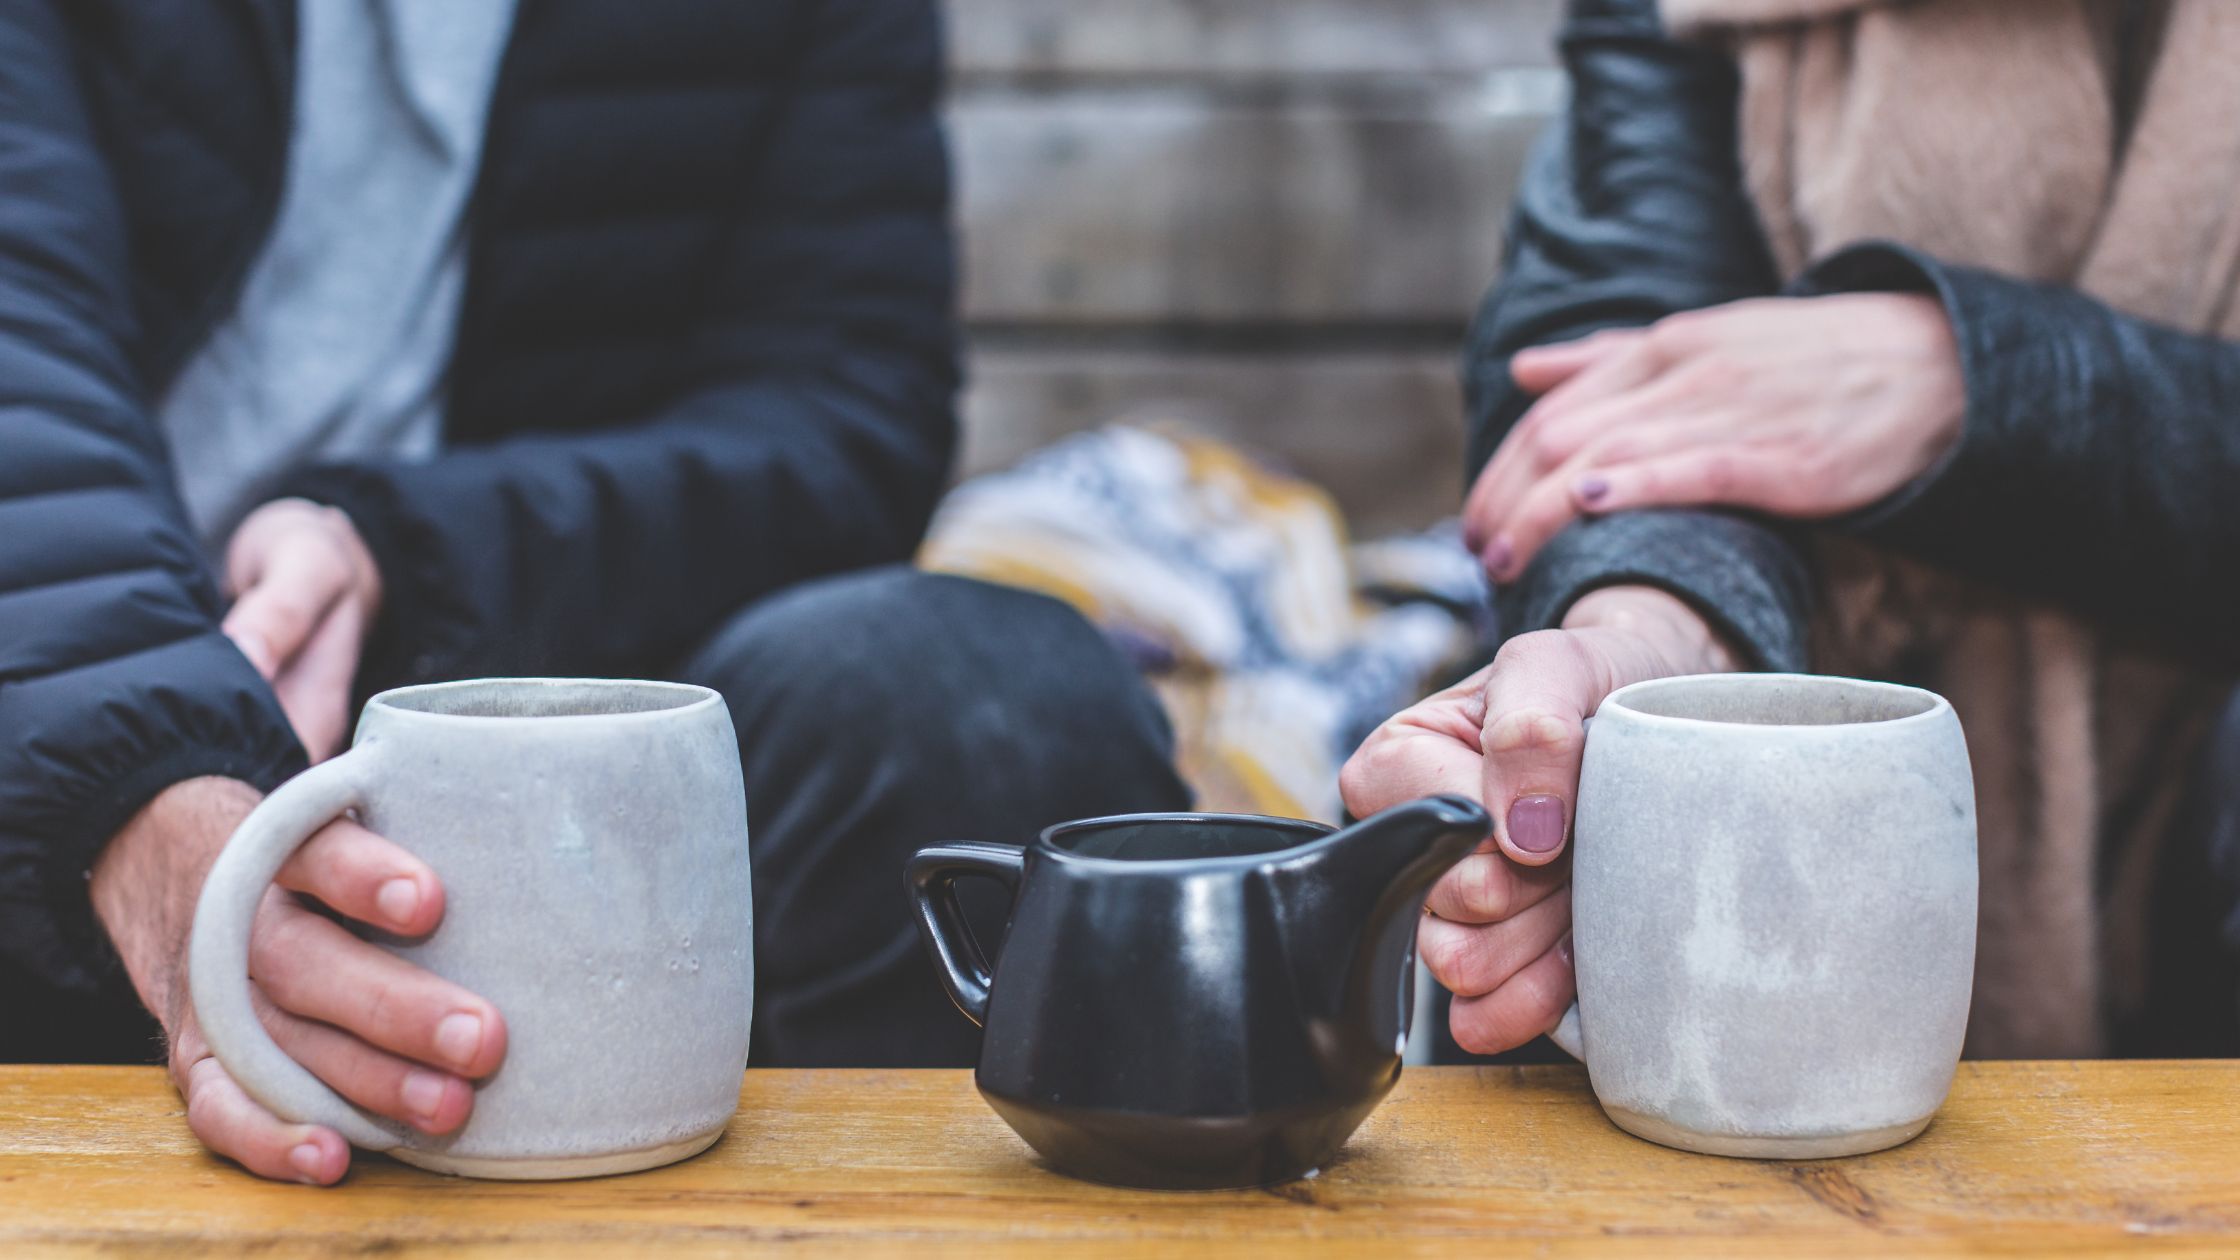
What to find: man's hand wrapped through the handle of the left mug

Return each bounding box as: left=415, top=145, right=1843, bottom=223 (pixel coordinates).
left=92, top=778, right=506, bottom=1186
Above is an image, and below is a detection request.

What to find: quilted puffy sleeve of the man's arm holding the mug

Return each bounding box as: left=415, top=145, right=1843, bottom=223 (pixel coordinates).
left=0, top=0, right=302, bottom=989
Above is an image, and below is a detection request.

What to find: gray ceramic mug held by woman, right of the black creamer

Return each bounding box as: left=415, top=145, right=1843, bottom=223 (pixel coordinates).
left=1555, top=675, right=1976, bottom=1159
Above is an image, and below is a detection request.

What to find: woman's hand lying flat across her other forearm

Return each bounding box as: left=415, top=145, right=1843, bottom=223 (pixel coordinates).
left=1463, top=294, right=1967, bottom=581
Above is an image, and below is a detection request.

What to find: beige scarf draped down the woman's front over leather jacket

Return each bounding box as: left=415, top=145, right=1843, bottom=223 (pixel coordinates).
left=1662, top=0, right=2240, bottom=1056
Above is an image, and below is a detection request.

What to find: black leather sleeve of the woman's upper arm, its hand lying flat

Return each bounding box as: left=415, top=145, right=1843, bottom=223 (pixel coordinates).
left=1792, top=244, right=2240, bottom=666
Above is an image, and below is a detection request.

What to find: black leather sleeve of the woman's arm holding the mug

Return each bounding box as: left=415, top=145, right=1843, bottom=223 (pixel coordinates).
left=1463, top=0, right=1810, bottom=670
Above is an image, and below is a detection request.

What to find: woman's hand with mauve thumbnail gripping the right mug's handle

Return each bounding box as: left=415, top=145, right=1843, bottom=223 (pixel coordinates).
left=1340, top=587, right=1736, bottom=1054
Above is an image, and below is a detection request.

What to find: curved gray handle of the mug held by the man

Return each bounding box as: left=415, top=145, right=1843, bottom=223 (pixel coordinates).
left=186, top=744, right=405, bottom=1150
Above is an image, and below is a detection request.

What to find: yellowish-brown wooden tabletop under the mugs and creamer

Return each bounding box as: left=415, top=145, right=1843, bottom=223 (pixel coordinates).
left=0, top=1063, right=2240, bottom=1260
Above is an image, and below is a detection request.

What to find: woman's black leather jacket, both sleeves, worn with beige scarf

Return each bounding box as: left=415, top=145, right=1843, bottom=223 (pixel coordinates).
left=1465, top=0, right=2240, bottom=668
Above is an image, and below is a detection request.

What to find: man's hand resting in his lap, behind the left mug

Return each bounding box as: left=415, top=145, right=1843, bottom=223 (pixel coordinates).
left=224, top=498, right=381, bottom=765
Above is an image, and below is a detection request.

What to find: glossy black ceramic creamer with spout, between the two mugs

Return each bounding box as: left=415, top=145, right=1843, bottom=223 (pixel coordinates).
left=907, top=796, right=1492, bottom=1188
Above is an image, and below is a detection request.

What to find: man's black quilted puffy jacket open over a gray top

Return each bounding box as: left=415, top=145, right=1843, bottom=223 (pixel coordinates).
left=0, top=0, right=954, bottom=1056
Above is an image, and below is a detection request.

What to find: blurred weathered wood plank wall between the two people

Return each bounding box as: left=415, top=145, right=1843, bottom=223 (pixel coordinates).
left=948, top=0, right=1564, bottom=536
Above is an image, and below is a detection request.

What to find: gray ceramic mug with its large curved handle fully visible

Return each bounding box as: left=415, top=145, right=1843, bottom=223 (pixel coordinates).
left=188, top=679, right=755, bottom=1179
